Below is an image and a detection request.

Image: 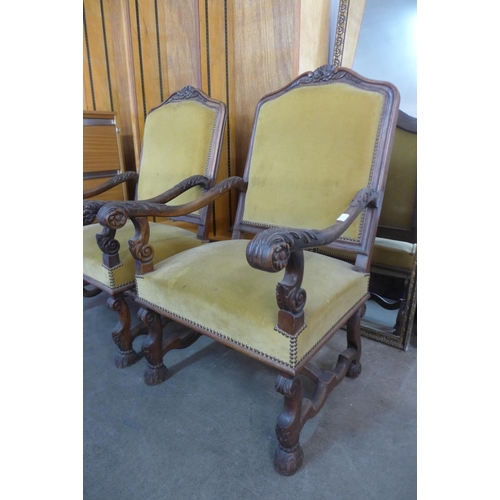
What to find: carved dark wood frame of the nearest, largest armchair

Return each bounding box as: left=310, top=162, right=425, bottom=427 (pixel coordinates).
left=97, top=66, right=399, bottom=475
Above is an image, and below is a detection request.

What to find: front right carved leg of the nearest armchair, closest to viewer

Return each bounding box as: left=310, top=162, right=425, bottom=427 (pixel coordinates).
left=274, top=374, right=304, bottom=476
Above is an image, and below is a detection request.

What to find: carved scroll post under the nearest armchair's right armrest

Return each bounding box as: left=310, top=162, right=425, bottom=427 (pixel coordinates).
left=276, top=250, right=306, bottom=335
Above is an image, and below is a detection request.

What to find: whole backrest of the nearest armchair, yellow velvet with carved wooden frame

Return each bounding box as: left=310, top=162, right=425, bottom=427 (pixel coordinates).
left=232, top=66, right=399, bottom=258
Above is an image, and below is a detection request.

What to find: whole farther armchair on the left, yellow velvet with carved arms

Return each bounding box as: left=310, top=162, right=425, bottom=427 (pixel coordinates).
left=83, top=86, right=226, bottom=368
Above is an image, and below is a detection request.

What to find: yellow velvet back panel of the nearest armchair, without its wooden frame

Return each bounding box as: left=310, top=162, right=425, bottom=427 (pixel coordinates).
left=243, top=83, right=383, bottom=240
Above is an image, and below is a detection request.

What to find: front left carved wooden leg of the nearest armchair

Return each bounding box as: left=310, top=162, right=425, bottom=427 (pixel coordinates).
left=138, top=308, right=168, bottom=385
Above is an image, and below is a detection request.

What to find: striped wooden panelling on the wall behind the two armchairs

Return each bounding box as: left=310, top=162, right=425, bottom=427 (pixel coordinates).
left=83, top=0, right=364, bottom=237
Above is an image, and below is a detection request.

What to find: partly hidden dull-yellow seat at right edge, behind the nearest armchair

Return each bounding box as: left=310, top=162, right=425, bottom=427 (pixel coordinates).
left=318, top=238, right=417, bottom=273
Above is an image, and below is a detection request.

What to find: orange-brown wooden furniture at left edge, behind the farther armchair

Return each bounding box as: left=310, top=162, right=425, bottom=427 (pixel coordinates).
left=83, top=111, right=128, bottom=200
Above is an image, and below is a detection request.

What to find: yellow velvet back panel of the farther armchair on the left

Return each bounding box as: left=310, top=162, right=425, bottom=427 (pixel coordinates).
left=137, top=101, right=216, bottom=205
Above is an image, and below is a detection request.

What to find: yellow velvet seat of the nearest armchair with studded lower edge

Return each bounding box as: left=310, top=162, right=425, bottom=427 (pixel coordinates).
left=136, top=240, right=369, bottom=369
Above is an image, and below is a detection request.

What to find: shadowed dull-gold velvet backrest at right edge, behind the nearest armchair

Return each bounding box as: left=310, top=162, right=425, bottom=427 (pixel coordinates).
left=379, top=128, right=417, bottom=230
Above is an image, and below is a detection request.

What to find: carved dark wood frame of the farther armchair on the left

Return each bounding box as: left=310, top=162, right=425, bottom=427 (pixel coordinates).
left=83, top=85, right=227, bottom=368
